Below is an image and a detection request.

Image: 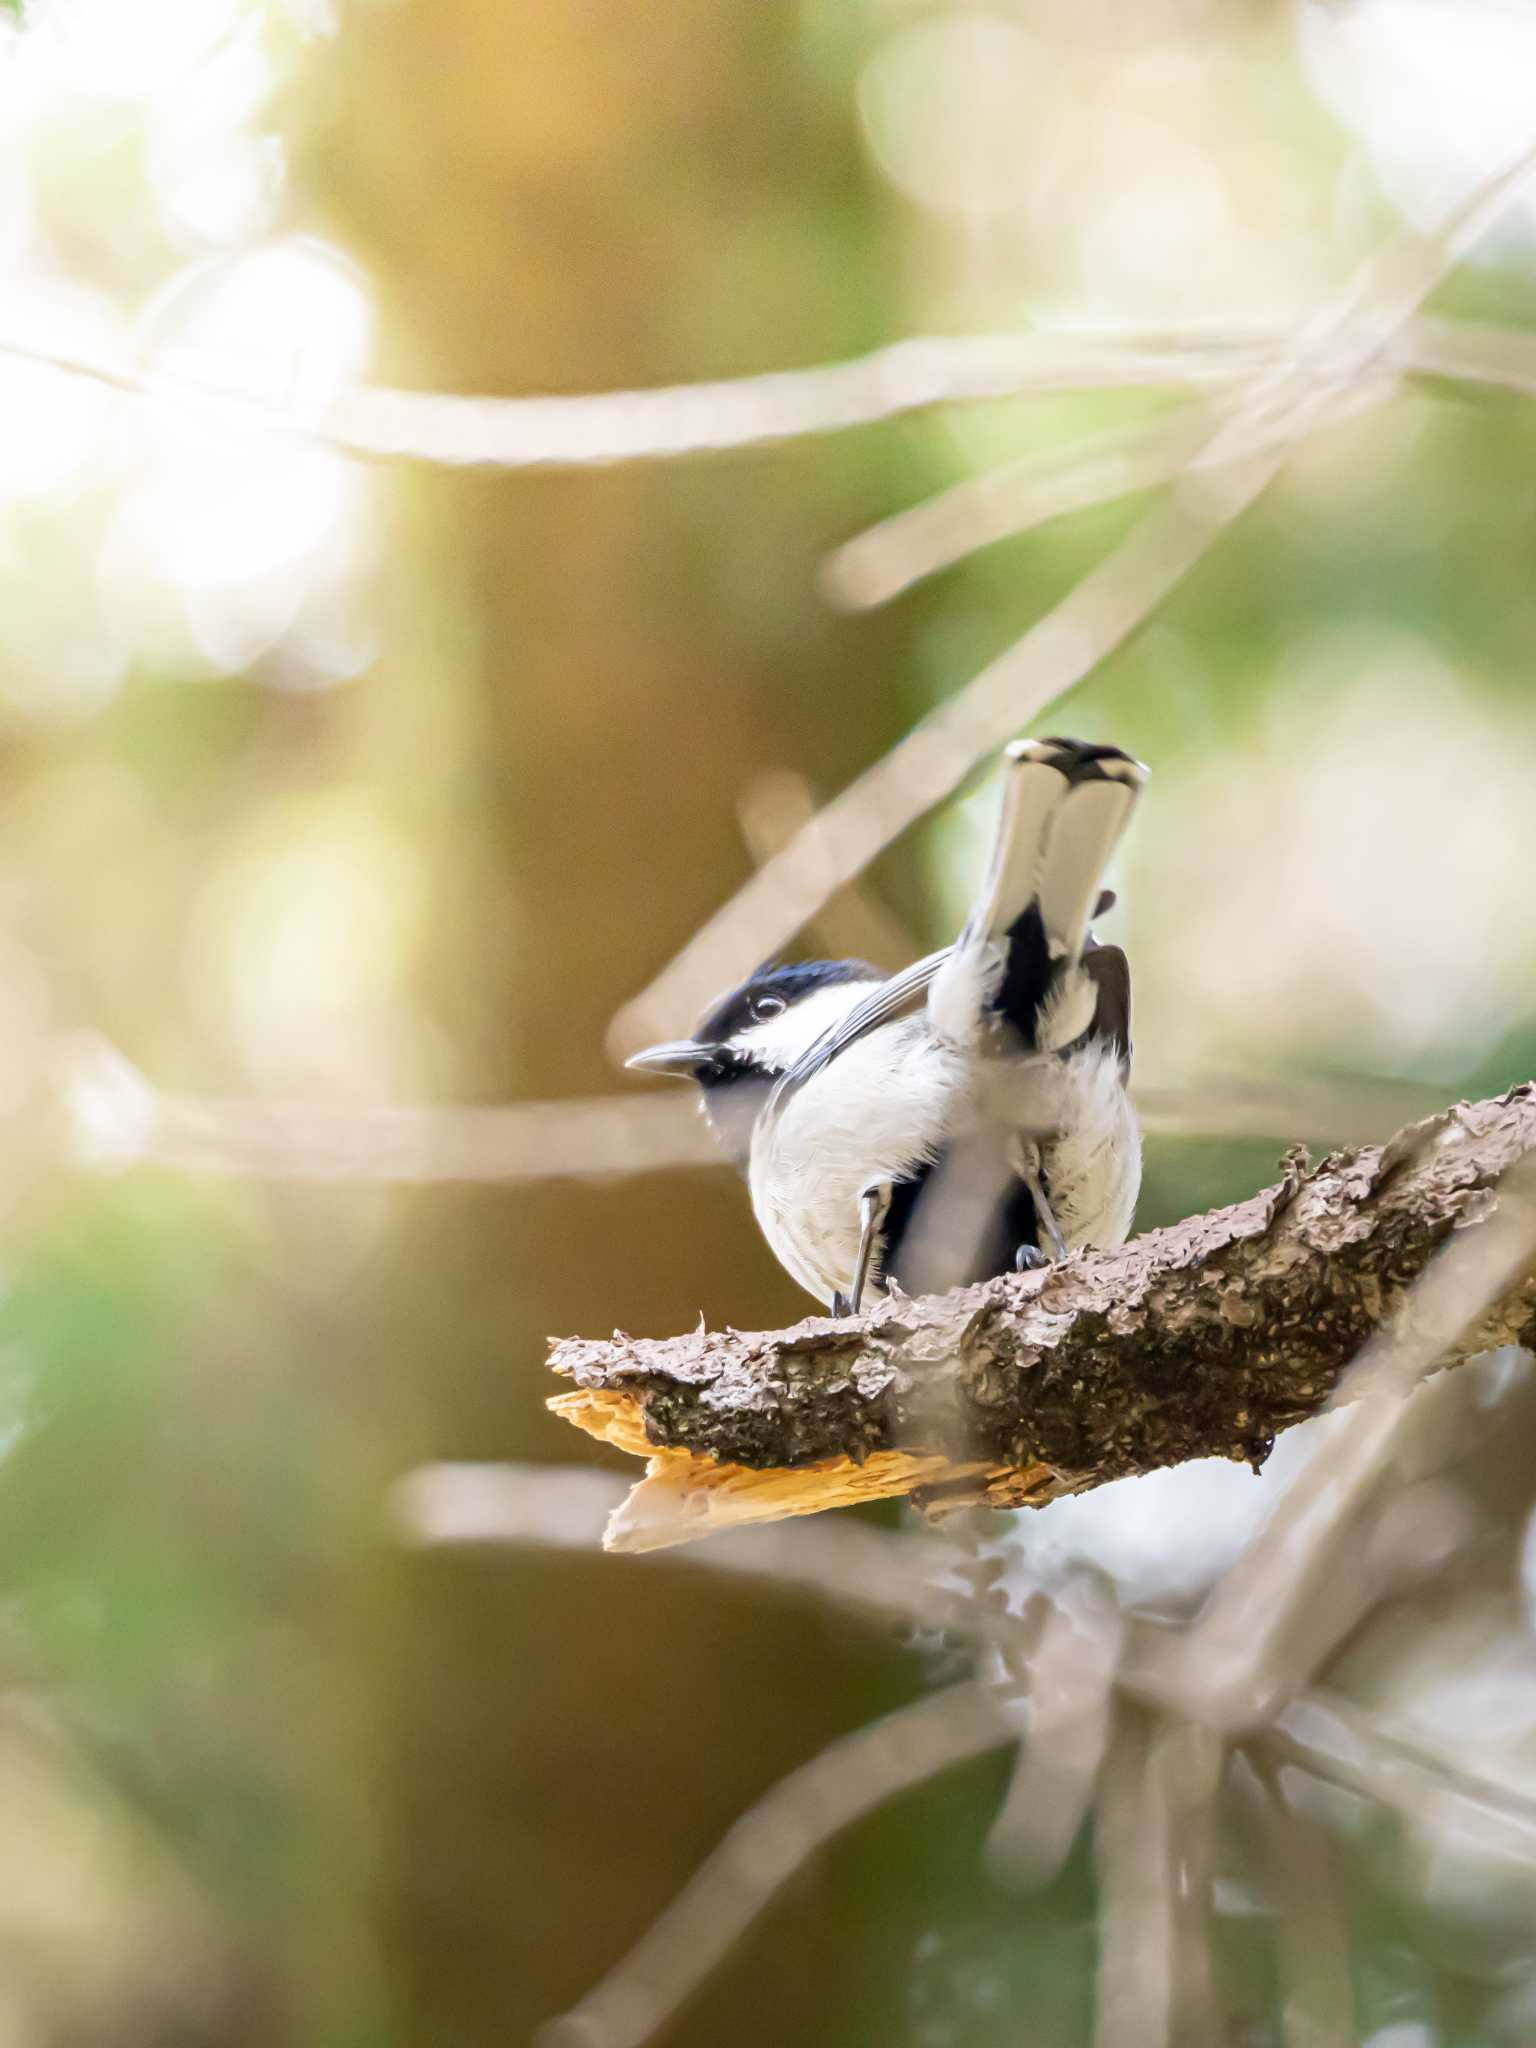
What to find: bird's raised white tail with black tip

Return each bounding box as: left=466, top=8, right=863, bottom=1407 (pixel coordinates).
left=928, top=739, right=1147, bottom=1053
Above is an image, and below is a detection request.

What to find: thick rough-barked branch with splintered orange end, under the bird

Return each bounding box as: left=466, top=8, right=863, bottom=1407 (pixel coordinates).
left=549, top=1083, right=1536, bottom=1550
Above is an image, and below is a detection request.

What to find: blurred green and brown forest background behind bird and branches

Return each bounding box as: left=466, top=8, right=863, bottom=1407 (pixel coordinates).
left=0, top=0, right=1536, bottom=2048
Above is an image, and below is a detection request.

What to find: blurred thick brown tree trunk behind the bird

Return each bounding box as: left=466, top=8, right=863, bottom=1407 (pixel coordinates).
left=309, top=0, right=937, bottom=2048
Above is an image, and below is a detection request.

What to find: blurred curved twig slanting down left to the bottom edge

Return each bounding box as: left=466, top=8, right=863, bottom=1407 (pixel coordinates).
left=539, top=1683, right=1018, bottom=2048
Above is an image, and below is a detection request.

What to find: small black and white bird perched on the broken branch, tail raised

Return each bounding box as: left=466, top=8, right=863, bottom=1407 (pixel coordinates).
left=629, top=739, right=1147, bottom=1315
